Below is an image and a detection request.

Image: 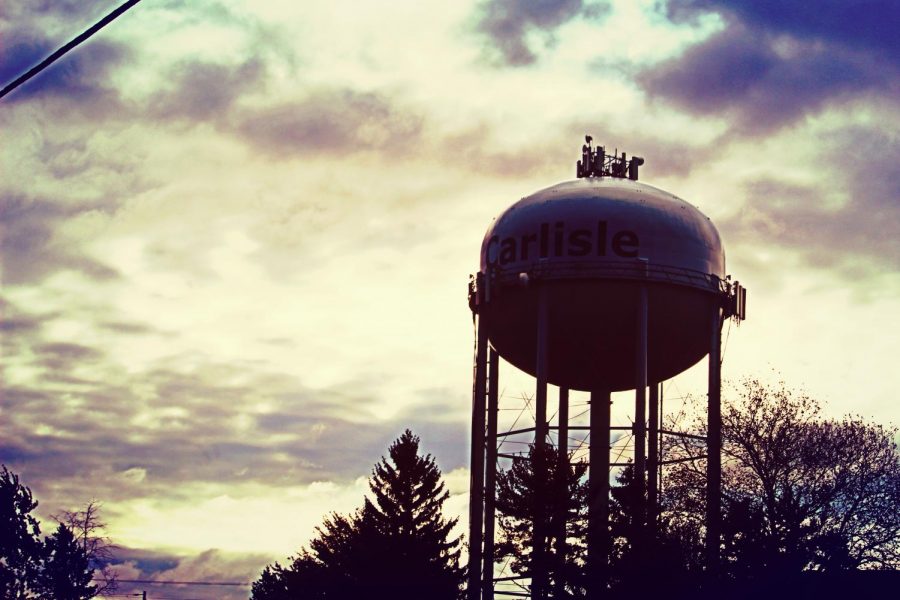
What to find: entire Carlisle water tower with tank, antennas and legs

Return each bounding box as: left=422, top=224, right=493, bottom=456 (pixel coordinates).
left=468, top=136, right=746, bottom=600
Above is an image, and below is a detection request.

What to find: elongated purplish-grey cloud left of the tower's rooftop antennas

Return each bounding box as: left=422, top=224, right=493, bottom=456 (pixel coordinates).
left=233, top=89, right=423, bottom=156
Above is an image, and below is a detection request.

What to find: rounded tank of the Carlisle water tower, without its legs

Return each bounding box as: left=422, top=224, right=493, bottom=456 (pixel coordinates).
left=481, top=177, right=725, bottom=391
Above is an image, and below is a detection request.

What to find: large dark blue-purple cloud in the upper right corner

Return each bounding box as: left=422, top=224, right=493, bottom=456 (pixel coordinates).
left=636, top=1, right=900, bottom=134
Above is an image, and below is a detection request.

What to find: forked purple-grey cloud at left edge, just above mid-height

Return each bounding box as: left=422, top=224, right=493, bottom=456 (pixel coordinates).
left=0, top=192, right=118, bottom=284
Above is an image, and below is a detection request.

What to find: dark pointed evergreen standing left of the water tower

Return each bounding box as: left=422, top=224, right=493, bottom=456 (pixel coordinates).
left=252, top=430, right=464, bottom=600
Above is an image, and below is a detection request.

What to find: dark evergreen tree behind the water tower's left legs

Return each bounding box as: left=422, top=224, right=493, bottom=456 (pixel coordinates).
left=496, top=445, right=587, bottom=598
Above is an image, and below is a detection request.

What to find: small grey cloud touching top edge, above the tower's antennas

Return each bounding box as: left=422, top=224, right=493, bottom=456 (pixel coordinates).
left=475, top=0, right=609, bottom=67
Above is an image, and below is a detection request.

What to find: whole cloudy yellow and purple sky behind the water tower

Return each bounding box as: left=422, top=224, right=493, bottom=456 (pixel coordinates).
left=0, top=0, right=900, bottom=598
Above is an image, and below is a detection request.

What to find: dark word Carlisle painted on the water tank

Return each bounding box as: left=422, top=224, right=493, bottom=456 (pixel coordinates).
left=487, top=221, right=640, bottom=265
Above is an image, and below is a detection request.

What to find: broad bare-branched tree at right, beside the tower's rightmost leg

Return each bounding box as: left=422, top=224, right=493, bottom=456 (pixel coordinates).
left=664, top=380, right=900, bottom=578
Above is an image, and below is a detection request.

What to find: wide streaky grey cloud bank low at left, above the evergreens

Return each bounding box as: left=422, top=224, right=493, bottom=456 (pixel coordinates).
left=0, top=335, right=465, bottom=508
